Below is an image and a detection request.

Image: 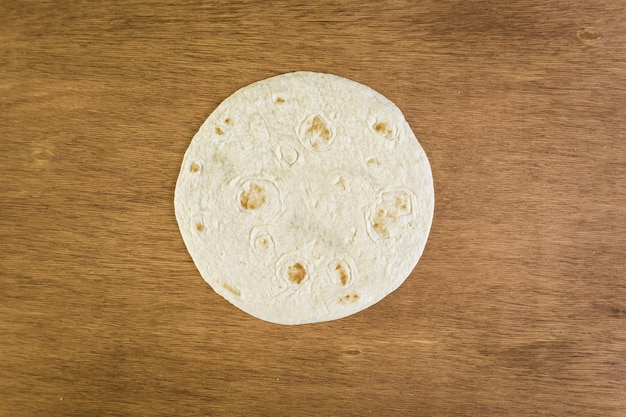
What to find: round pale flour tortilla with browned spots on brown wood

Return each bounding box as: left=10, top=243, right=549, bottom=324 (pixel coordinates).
left=174, top=72, right=434, bottom=324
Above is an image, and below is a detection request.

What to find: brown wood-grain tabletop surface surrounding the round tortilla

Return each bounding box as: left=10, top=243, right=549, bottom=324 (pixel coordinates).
left=0, top=0, right=626, bottom=417
